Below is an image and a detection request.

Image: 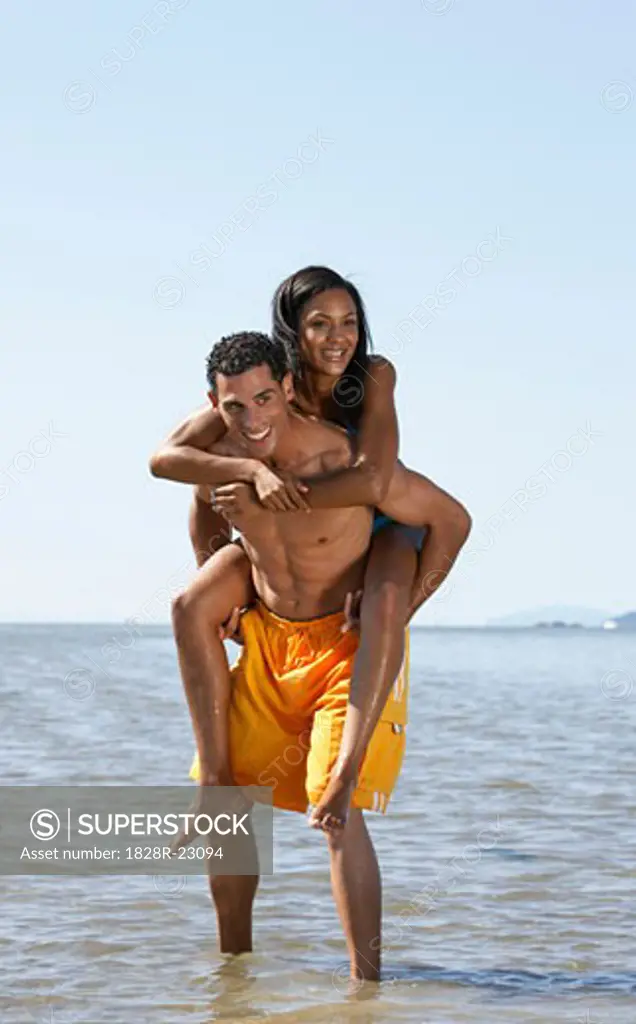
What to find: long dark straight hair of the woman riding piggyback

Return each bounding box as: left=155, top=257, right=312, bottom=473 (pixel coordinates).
left=271, top=266, right=373, bottom=427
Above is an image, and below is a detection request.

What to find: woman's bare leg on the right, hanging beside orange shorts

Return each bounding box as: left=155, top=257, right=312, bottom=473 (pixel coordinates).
left=309, top=526, right=418, bottom=830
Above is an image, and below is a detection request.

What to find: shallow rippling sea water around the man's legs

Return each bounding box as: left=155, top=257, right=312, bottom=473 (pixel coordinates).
left=0, top=626, right=636, bottom=1024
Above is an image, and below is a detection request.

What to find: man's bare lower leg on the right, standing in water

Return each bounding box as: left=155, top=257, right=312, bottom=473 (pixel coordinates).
left=327, top=808, right=382, bottom=981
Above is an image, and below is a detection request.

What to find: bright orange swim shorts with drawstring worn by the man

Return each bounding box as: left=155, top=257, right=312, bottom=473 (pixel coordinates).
left=189, top=604, right=409, bottom=812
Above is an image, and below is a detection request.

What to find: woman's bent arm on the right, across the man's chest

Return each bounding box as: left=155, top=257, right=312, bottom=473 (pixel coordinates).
left=306, top=357, right=398, bottom=509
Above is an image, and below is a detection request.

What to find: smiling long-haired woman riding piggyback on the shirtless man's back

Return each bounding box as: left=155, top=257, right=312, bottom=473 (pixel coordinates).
left=151, top=266, right=470, bottom=831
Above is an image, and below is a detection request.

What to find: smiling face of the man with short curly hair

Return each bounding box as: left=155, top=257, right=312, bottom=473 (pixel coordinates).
left=210, top=364, right=292, bottom=459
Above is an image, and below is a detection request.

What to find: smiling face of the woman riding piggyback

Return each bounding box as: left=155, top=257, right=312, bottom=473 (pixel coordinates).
left=299, top=288, right=357, bottom=377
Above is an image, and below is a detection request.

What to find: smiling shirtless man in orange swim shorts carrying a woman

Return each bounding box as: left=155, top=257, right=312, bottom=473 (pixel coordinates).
left=158, top=333, right=407, bottom=979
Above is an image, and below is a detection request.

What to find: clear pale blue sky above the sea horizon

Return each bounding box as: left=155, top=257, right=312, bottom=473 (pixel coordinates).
left=0, top=0, right=636, bottom=624
